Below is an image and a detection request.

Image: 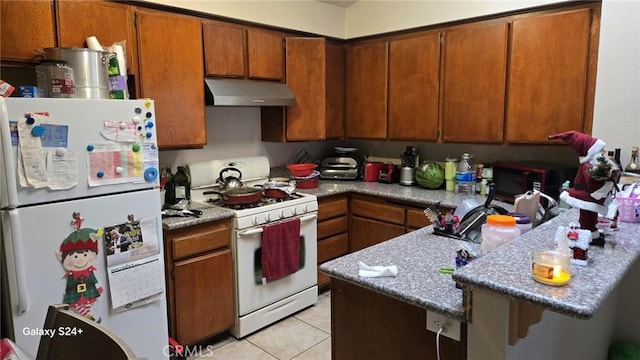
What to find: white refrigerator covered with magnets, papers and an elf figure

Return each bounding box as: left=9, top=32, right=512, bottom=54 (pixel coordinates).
left=0, top=98, right=169, bottom=359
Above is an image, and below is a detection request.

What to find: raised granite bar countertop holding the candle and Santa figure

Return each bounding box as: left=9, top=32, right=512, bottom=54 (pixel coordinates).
left=453, top=209, right=640, bottom=319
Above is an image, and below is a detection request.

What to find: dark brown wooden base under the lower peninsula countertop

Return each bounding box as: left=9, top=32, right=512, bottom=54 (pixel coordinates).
left=331, top=278, right=467, bottom=360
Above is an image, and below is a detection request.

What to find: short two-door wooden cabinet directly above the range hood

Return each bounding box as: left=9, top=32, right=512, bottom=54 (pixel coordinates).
left=202, top=21, right=284, bottom=81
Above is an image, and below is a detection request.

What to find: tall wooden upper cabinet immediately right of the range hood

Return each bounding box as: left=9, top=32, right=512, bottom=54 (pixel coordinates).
left=286, top=37, right=344, bottom=141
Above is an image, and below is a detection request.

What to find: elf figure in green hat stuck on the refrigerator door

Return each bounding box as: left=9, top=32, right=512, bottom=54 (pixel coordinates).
left=56, top=228, right=103, bottom=322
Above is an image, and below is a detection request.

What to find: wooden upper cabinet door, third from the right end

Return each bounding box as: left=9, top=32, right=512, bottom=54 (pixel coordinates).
left=389, top=33, right=440, bottom=141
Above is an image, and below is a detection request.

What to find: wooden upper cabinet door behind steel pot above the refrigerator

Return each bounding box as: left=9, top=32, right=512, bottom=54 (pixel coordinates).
left=56, top=0, right=137, bottom=74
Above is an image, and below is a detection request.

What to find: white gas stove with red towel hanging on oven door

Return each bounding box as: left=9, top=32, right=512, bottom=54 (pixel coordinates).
left=188, top=156, right=318, bottom=338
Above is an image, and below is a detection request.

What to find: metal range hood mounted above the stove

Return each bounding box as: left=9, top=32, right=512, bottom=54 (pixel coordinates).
left=204, top=79, right=296, bottom=106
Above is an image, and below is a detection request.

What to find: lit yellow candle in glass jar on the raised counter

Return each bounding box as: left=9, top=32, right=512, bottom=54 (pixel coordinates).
left=531, top=250, right=571, bottom=286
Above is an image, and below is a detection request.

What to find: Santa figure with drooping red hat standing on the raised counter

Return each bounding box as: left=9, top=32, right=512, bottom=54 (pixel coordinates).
left=549, top=130, right=620, bottom=246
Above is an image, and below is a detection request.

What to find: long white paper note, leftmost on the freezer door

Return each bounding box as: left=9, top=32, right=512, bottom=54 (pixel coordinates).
left=18, top=114, right=48, bottom=188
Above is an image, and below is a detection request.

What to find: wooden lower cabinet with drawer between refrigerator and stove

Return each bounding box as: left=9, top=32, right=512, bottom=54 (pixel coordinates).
left=164, top=220, right=235, bottom=345
